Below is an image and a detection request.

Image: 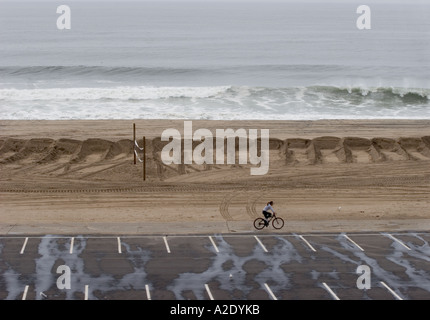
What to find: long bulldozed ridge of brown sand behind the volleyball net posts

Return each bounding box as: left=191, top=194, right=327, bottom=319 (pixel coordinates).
left=0, top=136, right=430, bottom=188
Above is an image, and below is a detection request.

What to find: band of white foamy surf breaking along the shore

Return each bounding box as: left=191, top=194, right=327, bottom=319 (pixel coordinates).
left=0, top=86, right=430, bottom=120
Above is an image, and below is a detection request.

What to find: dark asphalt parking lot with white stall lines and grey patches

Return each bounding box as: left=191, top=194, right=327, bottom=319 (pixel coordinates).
left=0, top=232, right=430, bottom=300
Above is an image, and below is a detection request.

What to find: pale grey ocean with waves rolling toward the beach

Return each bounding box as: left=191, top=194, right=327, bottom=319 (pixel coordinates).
left=0, top=0, right=430, bottom=120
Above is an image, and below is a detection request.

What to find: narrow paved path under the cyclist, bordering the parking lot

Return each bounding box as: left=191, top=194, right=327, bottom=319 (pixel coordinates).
left=0, top=219, right=430, bottom=235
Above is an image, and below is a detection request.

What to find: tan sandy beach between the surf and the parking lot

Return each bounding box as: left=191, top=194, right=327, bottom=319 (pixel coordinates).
left=0, top=120, right=430, bottom=234
